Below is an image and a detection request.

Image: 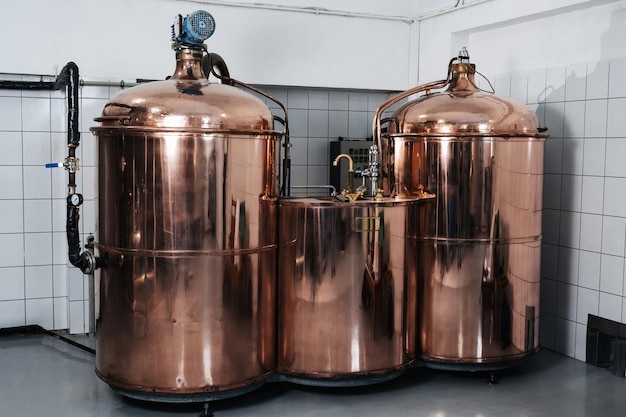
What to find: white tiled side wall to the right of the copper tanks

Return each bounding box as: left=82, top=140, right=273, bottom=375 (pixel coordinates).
left=494, top=58, right=626, bottom=360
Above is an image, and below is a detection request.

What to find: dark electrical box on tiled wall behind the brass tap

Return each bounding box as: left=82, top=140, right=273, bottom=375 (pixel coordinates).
left=330, top=140, right=373, bottom=193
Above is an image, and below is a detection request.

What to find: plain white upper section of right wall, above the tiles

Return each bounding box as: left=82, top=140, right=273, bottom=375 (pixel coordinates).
left=418, top=0, right=626, bottom=81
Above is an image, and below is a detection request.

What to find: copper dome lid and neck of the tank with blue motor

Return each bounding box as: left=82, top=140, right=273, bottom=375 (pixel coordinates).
left=92, top=47, right=278, bottom=134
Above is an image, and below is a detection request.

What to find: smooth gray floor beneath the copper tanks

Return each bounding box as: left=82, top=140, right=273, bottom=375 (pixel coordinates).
left=0, top=334, right=626, bottom=417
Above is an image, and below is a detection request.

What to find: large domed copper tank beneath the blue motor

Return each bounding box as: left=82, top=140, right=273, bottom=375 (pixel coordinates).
left=92, top=45, right=281, bottom=401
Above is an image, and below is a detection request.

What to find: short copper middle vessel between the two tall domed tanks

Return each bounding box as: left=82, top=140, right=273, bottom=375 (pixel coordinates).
left=278, top=197, right=426, bottom=380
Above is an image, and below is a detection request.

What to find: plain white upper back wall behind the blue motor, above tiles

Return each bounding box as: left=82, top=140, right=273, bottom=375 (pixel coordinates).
left=0, top=0, right=413, bottom=90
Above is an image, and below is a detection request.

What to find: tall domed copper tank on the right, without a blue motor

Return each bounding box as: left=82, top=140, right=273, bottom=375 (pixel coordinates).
left=374, top=52, right=547, bottom=368
